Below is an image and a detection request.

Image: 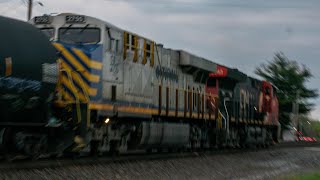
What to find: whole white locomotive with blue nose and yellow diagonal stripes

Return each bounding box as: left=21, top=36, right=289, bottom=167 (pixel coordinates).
left=30, top=13, right=217, bottom=152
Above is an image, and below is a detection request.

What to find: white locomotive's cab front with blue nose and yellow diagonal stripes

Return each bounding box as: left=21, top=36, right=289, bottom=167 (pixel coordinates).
left=29, top=13, right=105, bottom=121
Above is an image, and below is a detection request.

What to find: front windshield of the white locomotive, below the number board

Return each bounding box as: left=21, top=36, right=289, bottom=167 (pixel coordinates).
left=59, top=27, right=100, bottom=44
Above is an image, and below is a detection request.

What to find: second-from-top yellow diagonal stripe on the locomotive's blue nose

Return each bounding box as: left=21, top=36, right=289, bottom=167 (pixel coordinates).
left=53, top=43, right=100, bottom=83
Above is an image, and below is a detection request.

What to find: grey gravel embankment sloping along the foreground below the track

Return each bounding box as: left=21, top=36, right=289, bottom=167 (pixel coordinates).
left=0, top=147, right=320, bottom=179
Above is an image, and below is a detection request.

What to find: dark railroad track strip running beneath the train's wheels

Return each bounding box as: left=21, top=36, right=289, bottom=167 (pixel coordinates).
left=0, top=142, right=320, bottom=172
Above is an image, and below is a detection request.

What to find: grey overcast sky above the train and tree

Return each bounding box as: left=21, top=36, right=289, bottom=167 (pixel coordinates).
left=0, top=0, right=320, bottom=119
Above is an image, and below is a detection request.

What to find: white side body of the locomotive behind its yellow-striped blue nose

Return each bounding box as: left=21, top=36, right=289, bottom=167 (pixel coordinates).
left=97, top=28, right=214, bottom=118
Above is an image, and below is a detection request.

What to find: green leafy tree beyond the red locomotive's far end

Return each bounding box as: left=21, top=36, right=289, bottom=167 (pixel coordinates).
left=255, top=52, right=318, bottom=128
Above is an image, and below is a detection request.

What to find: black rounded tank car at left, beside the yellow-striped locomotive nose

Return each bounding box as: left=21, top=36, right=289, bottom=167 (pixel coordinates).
left=0, top=16, right=58, bottom=156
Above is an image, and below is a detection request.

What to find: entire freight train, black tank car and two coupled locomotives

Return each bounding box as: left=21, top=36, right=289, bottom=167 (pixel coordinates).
left=0, top=13, right=279, bottom=157
